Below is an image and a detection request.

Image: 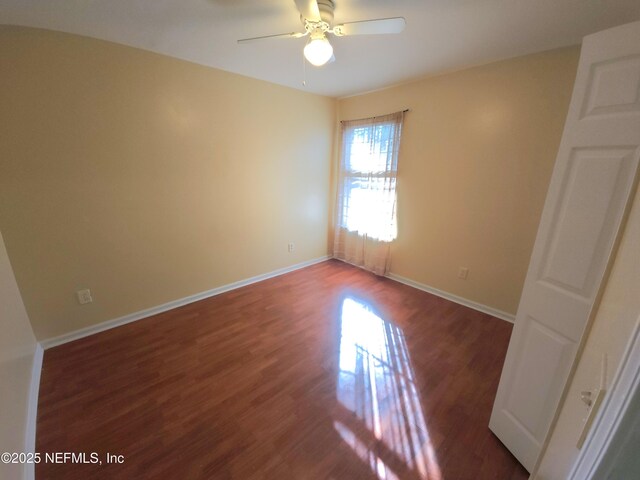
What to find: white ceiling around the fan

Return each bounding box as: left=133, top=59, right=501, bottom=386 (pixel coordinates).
left=0, top=0, right=640, bottom=97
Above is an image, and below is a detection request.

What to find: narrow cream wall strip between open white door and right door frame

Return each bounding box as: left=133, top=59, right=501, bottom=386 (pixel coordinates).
left=534, top=183, right=640, bottom=480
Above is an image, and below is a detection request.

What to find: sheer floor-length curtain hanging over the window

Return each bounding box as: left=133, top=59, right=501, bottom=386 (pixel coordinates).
left=333, top=112, right=404, bottom=275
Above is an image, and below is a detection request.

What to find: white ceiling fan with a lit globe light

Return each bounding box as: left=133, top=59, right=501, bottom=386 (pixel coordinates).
left=238, top=0, right=406, bottom=67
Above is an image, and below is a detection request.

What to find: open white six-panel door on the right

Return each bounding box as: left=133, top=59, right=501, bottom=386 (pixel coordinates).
left=489, top=22, right=640, bottom=471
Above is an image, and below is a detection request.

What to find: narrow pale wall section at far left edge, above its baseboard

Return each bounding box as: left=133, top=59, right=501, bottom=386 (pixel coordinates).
left=0, top=234, right=36, bottom=478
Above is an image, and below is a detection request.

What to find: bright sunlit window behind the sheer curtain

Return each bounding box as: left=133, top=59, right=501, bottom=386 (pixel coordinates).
left=337, top=112, right=403, bottom=242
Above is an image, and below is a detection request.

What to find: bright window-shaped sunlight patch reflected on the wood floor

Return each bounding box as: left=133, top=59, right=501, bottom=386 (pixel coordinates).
left=334, top=297, right=442, bottom=480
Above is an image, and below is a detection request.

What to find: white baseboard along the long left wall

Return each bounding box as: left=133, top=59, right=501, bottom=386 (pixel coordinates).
left=41, top=255, right=331, bottom=349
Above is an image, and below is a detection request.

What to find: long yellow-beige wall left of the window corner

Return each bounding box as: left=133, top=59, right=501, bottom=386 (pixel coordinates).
left=0, top=27, right=336, bottom=339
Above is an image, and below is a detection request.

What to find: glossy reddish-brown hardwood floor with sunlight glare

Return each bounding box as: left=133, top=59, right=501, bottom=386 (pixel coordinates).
left=36, top=260, right=528, bottom=480
